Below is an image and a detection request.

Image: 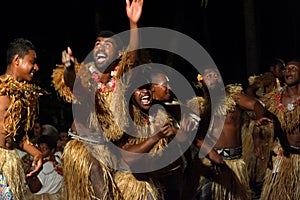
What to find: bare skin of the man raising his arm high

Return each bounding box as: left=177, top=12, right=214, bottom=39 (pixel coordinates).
left=58, top=0, right=143, bottom=199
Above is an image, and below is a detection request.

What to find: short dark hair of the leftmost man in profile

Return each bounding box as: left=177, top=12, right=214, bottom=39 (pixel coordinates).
left=6, top=38, right=36, bottom=64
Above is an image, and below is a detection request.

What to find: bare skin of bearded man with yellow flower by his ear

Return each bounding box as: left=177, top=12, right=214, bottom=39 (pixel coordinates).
left=195, top=69, right=271, bottom=170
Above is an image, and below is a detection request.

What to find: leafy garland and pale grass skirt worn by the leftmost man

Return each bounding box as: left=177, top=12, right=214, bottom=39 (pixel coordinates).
left=0, top=75, right=42, bottom=200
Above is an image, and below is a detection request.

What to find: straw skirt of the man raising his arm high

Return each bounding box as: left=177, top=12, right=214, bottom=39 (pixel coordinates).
left=62, top=140, right=119, bottom=200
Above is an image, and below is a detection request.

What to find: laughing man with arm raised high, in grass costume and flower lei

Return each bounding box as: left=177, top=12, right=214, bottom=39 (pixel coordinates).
left=52, top=0, right=143, bottom=199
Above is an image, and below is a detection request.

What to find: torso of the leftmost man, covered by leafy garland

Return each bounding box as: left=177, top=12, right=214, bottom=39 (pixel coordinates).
left=0, top=75, right=43, bottom=147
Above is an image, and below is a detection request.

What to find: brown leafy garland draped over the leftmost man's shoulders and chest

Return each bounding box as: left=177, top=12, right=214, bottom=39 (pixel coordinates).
left=0, top=75, right=43, bottom=136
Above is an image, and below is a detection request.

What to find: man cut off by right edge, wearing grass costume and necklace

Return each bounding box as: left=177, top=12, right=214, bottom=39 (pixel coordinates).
left=261, top=58, right=300, bottom=200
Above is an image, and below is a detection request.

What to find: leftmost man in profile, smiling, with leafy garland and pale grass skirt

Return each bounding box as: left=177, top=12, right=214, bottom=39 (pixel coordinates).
left=0, top=38, right=42, bottom=200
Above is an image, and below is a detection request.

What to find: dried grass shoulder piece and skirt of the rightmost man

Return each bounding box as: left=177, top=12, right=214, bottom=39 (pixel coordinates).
left=261, top=86, right=300, bottom=200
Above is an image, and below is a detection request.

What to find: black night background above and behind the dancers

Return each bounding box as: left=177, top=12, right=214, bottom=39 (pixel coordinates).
left=0, top=0, right=300, bottom=125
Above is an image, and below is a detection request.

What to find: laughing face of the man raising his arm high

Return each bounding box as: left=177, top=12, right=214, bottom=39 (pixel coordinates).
left=93, top=37, right=120, bottom=71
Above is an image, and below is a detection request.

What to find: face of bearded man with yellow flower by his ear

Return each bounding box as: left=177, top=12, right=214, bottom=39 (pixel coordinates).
left=203, top=69, right=222, bottom=89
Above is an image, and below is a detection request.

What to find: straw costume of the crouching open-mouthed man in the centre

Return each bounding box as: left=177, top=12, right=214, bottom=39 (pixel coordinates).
left=113, top=69, right=188, bottom=200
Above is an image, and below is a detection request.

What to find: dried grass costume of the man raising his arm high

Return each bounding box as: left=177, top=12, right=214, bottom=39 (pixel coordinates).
left=52, top=50, right=148, bottom=200
